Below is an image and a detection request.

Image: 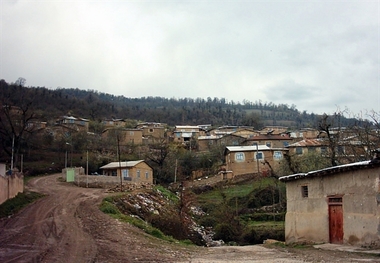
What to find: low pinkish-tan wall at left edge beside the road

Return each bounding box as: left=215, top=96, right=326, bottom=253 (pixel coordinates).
left=0, top=173, right=24, bottom=204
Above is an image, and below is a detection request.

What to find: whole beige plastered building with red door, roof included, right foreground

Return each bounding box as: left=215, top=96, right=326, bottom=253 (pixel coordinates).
left=279, top=159, right=380, bottom=248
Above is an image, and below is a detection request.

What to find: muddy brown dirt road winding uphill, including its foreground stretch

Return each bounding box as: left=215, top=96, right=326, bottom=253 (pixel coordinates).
left=0, top=175, right=376, bottom=263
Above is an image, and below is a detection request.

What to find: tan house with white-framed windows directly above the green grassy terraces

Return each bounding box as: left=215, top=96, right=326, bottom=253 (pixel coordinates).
left=224, top=145, right=287, bottom=176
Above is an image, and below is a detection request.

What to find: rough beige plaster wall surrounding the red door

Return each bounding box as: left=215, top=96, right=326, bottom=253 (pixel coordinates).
left=285, top=167, right=380, bottom=248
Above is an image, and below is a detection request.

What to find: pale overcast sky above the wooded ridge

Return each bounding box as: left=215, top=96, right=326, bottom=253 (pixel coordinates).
left=0, top=0, right=380, bottom=114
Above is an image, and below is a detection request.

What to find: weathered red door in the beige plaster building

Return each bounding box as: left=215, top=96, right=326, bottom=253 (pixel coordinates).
left=329, top=204, right=343, bottom=244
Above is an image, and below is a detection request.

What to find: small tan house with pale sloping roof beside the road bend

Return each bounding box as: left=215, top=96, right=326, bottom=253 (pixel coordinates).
left=100, top=160, right=153, bottom=184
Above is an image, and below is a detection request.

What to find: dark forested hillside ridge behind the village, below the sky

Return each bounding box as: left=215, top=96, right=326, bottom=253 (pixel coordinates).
left=0, top=80, right=360, bottom=128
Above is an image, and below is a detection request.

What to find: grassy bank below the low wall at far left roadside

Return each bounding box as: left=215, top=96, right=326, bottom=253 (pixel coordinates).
left=0, top=192, right=44, bottom=218
